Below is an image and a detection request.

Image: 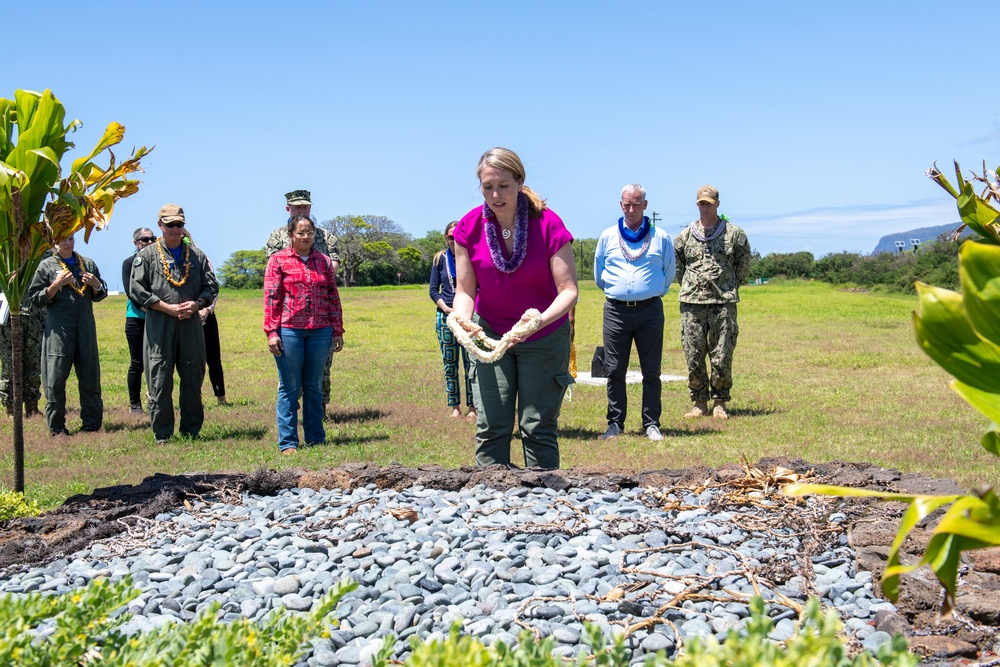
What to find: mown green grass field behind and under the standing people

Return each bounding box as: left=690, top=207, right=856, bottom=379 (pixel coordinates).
left=0, top=280, right=1000, bottom=507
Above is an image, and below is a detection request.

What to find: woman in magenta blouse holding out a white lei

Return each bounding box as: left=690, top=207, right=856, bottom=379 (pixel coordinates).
left=454, top=148, right=577, bottom=468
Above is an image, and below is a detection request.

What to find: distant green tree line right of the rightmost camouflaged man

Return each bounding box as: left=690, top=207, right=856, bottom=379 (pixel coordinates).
left=749, top=234, right=964, bottom=294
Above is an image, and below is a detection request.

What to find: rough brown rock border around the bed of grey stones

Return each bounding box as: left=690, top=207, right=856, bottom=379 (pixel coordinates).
left=0, top=458, right=1000, bottom=660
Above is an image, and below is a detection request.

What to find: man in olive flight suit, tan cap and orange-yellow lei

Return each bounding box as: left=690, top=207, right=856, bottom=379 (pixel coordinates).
left=128, top=204, right=219, bottom=445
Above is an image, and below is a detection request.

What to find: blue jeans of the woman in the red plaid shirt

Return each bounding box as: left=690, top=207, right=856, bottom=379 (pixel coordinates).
left=274, top=327, right=333, bottom=449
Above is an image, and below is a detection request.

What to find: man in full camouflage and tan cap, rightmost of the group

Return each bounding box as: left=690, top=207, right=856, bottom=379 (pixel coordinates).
left=674, top=185, right=750, bottom=419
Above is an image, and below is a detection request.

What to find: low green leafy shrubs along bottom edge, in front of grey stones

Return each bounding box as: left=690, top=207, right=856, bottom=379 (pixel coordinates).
left=0, top=579, right=917, bottom=667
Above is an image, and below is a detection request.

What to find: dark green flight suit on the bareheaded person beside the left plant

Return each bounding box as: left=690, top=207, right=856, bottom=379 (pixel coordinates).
left=28, top=253, right=108, bottom=433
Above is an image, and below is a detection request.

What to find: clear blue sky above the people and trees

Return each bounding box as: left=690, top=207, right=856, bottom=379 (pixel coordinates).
left=9, top=0, right=1000, bottom=289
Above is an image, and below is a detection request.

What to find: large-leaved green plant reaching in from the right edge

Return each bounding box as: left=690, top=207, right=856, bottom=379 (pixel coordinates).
left=785, top=162, right=1000, bottom=614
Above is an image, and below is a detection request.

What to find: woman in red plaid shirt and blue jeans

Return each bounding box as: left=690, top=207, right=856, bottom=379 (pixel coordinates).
left=264, top=215, right=344, bottom=454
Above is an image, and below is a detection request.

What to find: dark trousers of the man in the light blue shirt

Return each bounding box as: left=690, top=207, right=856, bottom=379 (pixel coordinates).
left=604, top=297, right=663, bottom=430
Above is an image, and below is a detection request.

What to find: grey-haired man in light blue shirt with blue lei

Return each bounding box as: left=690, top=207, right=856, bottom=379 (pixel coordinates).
left=594, top=183, right=675, bottom=440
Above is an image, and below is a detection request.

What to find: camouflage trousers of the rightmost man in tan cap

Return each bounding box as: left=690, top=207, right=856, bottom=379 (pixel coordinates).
left=681, top=302, right=740, bottom=402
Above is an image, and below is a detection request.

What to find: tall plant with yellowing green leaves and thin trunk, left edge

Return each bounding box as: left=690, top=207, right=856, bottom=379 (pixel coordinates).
left=0, top=90, right=149, bottom=492
